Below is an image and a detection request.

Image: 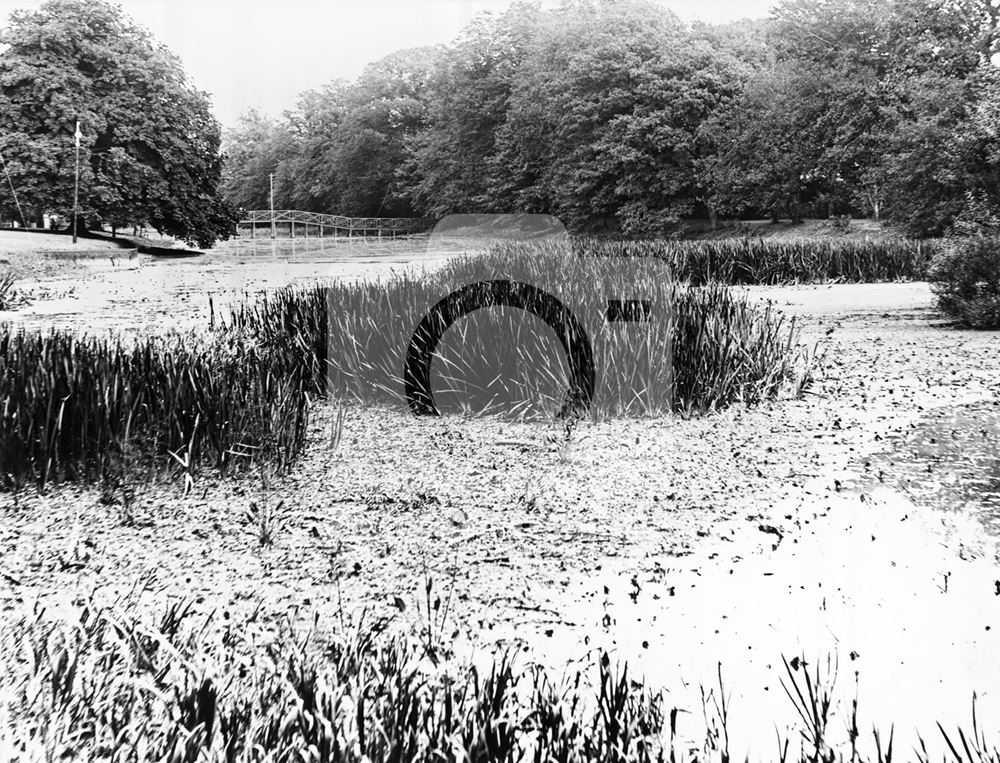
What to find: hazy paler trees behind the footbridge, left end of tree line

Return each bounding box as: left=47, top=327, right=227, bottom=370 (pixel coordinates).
left=222, top=48, right=433, bottom=217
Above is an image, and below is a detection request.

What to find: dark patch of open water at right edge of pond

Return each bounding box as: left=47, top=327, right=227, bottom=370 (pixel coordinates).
left=865, top=400, right=1000, bottom=534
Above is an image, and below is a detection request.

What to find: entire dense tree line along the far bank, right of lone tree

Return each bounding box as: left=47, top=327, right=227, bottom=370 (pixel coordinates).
left=224, top=0, right=1000, bottom=235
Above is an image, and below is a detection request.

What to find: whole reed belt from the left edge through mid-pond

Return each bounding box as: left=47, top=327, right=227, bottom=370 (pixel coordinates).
left=0, top=247, right=809, bottom=487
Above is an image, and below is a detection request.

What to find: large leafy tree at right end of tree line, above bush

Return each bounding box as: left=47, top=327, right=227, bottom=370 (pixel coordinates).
left=710, top=0, right=1000, bottom=235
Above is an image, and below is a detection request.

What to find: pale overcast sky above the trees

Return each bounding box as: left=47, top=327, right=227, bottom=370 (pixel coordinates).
left=0, top=0, right=773, bottom=124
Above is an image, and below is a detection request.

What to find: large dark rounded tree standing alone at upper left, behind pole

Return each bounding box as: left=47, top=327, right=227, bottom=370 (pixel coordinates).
left=0, top=0, right=234, bottom=246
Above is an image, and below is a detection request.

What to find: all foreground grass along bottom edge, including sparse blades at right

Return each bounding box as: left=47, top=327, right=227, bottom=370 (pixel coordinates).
left=0, top=596, right=1000, bottom=763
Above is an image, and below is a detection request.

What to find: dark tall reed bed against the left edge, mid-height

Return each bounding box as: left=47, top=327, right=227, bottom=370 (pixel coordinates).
left=0, top=327, right=309, bottom=487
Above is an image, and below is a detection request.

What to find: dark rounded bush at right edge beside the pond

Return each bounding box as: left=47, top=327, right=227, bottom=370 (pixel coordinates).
left=929, top=235, right=1000, bottom=329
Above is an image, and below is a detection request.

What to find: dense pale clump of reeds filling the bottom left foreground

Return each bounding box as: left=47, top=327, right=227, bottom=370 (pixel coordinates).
left=0, top=604, right=663, bottom=763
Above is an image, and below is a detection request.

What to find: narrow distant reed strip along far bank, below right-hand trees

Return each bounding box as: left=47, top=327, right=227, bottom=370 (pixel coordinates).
left=573, top=238, right=939, bottom=285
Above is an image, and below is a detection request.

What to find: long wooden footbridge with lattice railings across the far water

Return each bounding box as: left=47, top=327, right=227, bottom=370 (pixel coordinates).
left=237, top=209, right=435, bottom=238
